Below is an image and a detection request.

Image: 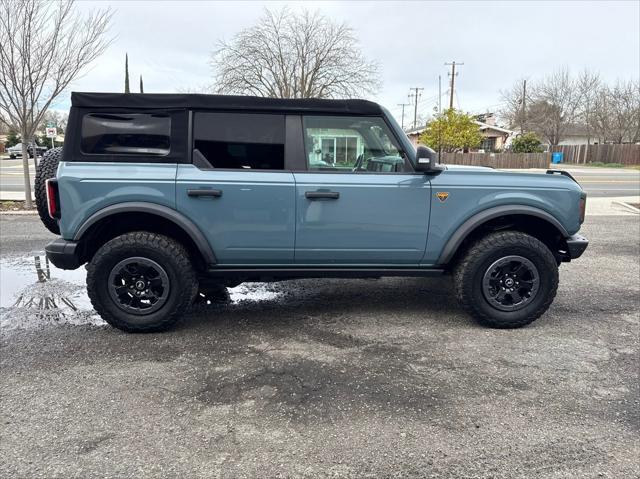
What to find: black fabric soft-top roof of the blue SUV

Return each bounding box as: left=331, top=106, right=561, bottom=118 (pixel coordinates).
left=71, top=92, right=382, bottom=115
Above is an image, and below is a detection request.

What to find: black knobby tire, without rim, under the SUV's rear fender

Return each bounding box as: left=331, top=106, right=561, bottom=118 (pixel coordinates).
left=87, top=231, right=198, bottom=333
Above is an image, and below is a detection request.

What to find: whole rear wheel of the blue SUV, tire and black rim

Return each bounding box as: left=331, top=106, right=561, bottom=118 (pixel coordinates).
left=87, top=232, right=198, bottom=333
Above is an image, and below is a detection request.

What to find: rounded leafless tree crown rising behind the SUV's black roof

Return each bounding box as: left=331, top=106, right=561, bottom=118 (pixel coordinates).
left=211, top=8, right=379, bottom=98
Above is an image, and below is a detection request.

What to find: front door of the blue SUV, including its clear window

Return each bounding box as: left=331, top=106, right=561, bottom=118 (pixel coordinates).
left=294, top=116, right=431, bottom=266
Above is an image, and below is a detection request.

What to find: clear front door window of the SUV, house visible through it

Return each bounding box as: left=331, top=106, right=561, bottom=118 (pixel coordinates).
left=304, top=116, right=406, bottom=173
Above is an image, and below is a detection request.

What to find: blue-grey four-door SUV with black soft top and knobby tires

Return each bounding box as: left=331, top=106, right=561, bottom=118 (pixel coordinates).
left=36, top=93, right=588, bottom=332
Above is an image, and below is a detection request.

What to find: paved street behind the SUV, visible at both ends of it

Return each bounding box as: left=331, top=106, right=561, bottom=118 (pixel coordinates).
left=0, top=160, right=640, bottom=197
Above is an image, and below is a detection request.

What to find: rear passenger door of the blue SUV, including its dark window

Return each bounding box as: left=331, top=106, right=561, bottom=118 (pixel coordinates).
left=176, top=112, right=295, bottom=266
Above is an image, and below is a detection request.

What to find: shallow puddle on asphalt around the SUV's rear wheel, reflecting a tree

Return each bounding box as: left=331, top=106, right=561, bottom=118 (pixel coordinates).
left=0, top=253, right=282, bottom=330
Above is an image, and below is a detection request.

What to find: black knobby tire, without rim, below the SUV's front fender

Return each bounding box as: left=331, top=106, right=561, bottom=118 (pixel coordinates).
left=453, top=231, right=558, bottom=329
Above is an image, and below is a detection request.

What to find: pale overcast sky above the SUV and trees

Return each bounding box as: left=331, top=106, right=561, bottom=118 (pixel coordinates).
left=58, top=1, right=640, bottom=123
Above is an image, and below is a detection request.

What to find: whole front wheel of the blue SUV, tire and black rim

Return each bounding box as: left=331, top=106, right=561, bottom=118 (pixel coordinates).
left=453, top=231, right=558, bottom=328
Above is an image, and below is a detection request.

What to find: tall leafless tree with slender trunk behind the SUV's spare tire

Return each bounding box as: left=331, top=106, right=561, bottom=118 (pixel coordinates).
left=0, top=0, right=111, bottom=207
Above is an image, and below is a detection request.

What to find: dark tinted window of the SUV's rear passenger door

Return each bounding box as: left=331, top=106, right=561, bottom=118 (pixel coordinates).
left=193, top=112, right=284, bottom=170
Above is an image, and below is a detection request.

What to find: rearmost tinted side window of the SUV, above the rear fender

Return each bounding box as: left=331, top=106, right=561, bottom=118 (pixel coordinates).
left=81, top=113, right=171, bottom=156
